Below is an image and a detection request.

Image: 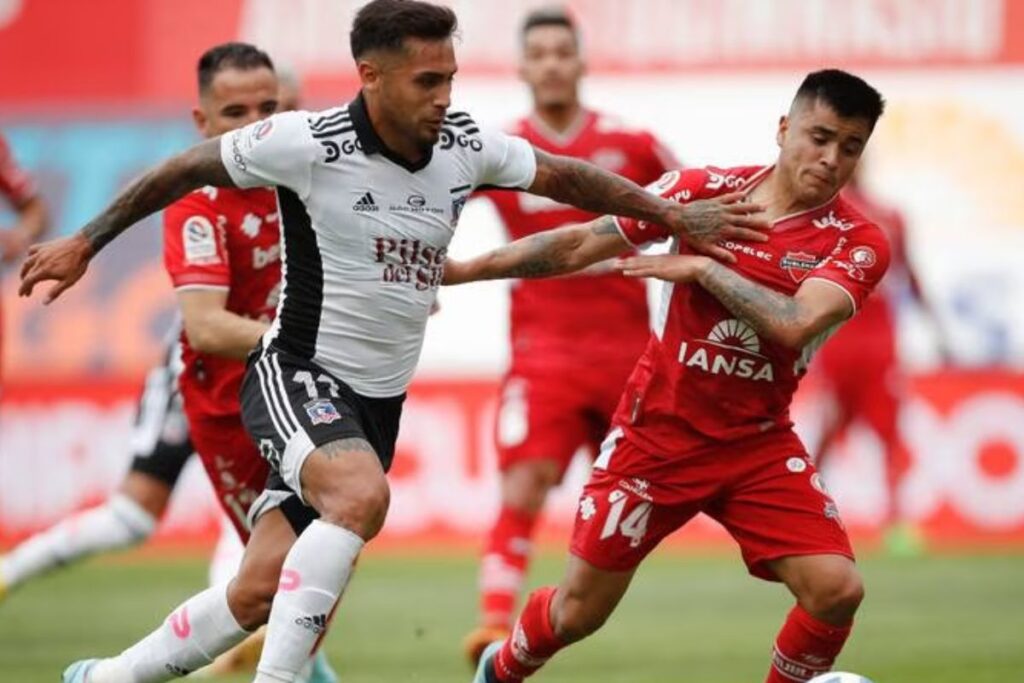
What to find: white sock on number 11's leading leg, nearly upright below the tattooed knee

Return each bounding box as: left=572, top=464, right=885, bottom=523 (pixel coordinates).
left=254, top=520, right=365, bottom=683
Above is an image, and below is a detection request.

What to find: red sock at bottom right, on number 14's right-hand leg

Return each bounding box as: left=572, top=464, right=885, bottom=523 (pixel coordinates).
left=765, top=605, right=853, bottom=683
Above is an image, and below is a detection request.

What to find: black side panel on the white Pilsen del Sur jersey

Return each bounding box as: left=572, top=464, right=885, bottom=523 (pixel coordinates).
left=273, top=187, right=324, bottom=359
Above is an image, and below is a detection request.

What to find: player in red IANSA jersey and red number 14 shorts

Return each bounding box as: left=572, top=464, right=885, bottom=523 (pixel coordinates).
left=445, top=70, right=889, bottom=683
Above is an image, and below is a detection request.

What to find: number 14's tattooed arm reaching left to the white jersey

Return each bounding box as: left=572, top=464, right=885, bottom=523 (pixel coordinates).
left=443, top=216, right=632, bottom=285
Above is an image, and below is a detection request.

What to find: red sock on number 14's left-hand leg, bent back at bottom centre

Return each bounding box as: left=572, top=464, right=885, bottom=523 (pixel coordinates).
left=495, top=586, right=565, bottom=683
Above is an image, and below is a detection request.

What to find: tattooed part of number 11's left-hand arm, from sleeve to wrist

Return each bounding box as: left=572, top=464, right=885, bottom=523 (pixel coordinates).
left=82, top=138, right=234, bottom=254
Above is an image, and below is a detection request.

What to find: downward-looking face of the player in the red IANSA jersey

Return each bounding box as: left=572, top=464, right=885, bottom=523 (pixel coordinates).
left=778, top=100, right=871, bottom=206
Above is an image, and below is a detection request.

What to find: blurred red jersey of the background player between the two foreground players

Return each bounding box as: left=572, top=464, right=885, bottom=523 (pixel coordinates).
left=488, top=111, right=678, bottom=367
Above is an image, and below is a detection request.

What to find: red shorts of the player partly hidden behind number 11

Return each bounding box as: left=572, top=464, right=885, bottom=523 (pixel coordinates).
left=185, top=405, right=269, bottom=542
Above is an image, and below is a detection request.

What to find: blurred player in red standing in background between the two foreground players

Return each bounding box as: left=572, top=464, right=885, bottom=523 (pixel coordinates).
left=465, top=10, right=679, bottom=665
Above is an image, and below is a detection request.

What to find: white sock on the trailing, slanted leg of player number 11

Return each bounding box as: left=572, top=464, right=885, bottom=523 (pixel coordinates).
left=89, top=584, right=249, bottom=683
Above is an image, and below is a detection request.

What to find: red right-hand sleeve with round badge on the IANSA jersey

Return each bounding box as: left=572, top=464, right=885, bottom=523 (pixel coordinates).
left=807, top=223, right=890, bottom=312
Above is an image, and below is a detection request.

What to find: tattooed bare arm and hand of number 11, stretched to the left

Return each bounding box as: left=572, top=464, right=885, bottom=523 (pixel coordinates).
left=18, top=138, right=234, bottom=303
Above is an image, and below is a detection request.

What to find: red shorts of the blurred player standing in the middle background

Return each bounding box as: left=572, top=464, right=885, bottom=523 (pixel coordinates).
left=495, top=373, right=591, bottom=480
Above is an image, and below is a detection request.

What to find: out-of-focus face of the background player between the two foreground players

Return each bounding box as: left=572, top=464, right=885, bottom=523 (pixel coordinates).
left=519, top=26, right=584, bottom=109
